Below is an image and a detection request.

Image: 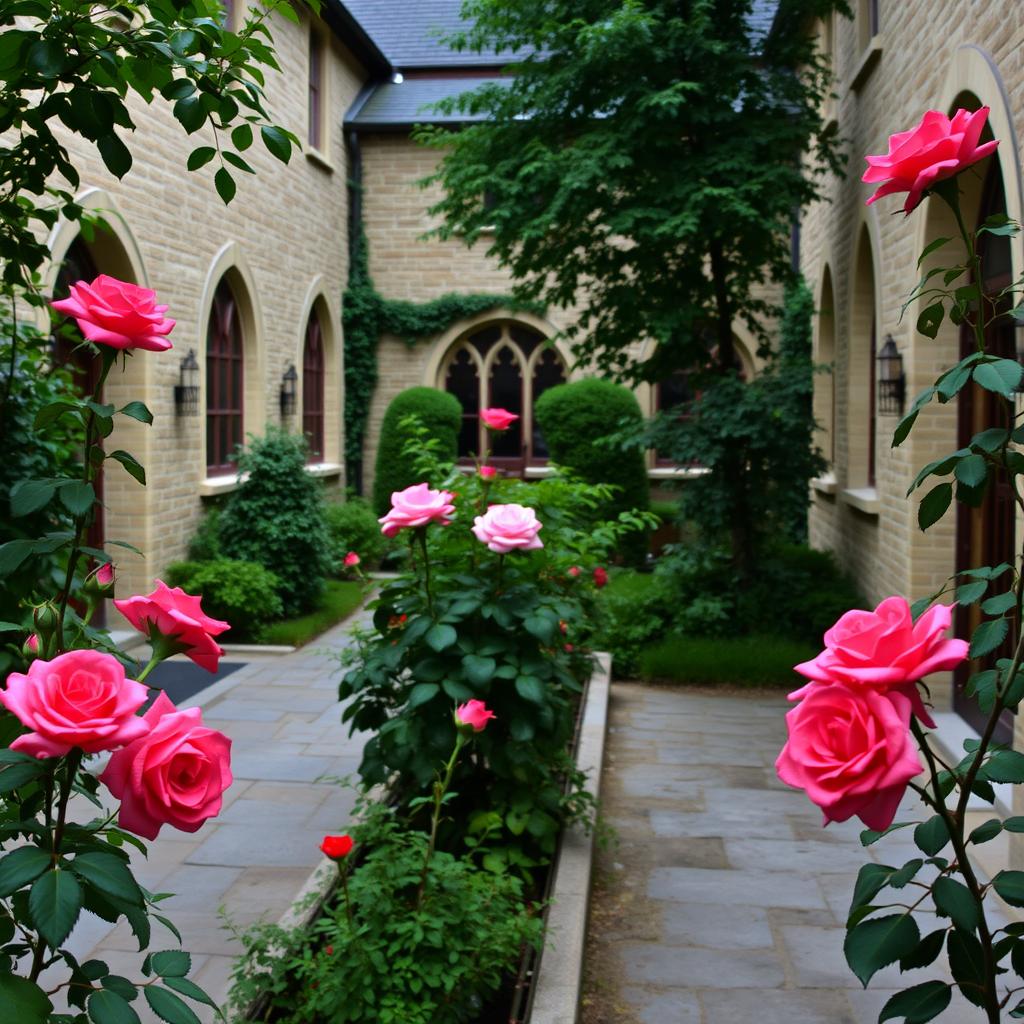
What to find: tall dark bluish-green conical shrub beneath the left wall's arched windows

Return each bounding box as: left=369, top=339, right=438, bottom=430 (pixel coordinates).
left=217, top=428, right=330, bottom=615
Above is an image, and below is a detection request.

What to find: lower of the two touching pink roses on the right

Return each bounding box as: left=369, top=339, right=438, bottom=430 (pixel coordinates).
left=775, top=683, right=924, bottom=831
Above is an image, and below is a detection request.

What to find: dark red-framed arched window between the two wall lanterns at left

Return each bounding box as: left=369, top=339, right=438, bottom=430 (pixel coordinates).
left=206, top=279, right=244, bottom=473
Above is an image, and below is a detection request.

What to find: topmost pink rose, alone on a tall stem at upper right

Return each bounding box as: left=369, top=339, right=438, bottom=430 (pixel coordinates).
left=861, top=106, right=999, bottom=213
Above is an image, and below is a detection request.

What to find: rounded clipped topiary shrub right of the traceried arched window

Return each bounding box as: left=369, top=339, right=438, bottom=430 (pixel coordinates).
left=534, top=378, right=650, bottom=562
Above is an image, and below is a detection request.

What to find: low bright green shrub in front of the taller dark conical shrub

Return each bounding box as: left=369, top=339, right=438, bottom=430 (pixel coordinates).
left=164, top=558, right=282, bottom=642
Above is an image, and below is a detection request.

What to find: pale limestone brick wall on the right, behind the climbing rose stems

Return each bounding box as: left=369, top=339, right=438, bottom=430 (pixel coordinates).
left=802, top=0, right=1024, bottom=614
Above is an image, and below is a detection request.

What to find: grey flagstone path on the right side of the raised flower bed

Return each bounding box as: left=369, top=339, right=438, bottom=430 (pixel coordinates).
left=583, top=683, right=1007, bottom=1024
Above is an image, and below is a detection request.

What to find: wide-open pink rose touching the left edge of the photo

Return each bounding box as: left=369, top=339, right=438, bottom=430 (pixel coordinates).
left=0, top=650, right=150, bottom=758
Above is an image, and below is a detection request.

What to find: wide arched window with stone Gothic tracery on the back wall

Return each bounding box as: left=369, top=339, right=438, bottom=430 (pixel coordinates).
left=441, top=322, right=566, bottom=472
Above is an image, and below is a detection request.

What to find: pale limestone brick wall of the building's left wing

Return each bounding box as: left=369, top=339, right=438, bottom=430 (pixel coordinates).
left=43, top=6, right=366, bottom=594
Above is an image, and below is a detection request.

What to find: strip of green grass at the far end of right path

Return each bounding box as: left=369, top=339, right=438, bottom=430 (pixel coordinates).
left=640, top=636, right=818, bottom=688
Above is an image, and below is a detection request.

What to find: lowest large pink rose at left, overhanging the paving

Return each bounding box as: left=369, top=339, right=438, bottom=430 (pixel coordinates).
left=99, top=692, right=231, bottom=839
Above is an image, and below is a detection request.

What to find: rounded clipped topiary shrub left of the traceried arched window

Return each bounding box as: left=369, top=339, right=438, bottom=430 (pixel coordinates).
left=374, top=387, right=462, bottom=516
